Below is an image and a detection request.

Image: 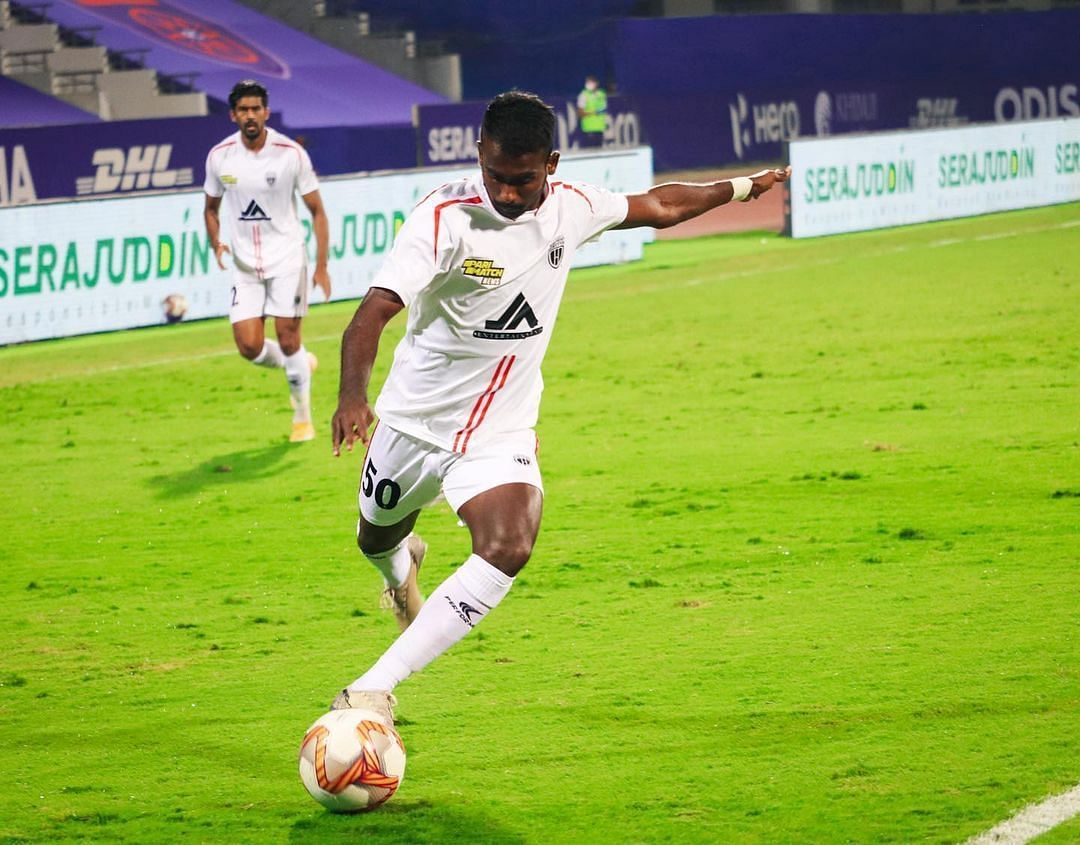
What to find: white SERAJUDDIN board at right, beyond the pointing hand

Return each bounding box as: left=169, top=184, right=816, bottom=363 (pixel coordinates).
left=787, top=119, right=1080, bottom=238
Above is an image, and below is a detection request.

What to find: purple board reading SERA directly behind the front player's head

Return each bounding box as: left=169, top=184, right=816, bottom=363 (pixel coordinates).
left=413, top=96, right=643, bottom=166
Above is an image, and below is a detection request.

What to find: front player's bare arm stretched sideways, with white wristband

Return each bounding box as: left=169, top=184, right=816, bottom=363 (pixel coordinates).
left=615, top=166, right=792, bottom=229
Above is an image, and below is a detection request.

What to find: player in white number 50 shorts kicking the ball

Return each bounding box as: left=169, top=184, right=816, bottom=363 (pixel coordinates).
left=332, top=91, right=791, bottom=724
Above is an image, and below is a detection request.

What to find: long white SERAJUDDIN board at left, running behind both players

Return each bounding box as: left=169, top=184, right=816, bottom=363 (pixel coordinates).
left=0, top=148, right=652, bottom=345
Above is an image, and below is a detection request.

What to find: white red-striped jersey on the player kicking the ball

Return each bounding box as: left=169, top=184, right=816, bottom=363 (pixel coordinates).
left=372, top=173, right=627, bottom=453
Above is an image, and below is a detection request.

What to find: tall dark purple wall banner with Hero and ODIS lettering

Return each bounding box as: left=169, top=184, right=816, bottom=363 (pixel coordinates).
left=611, top=10, right=1080, bottom=171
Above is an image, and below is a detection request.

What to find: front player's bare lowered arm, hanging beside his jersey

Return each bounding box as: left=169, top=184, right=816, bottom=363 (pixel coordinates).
left=330, top=287, right=405, bottom=455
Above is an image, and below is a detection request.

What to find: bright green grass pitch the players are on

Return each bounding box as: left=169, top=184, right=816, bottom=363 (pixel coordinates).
left=0, top=205, right=1080, bottom=844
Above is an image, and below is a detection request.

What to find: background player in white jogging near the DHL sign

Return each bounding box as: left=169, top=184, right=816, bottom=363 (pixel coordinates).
left=203, top=79, right=330, bottom=443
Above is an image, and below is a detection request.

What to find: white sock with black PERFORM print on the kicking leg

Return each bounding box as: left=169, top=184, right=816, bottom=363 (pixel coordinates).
left=349, top=554, right=514, bottom=690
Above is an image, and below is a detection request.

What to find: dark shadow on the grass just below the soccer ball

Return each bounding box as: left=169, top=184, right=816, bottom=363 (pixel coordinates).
left=288, top=801, right=525, bottom=845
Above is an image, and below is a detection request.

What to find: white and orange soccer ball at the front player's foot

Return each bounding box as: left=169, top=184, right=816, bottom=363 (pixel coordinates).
left=300, top=708, right=405, bottom=813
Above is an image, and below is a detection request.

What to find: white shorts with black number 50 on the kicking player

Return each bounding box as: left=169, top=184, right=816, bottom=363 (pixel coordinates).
left=360, top=424, right=543, bottom=525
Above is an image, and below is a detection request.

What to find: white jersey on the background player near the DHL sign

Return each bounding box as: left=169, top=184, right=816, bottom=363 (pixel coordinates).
left=203, top=126, right=319, bottom=279
